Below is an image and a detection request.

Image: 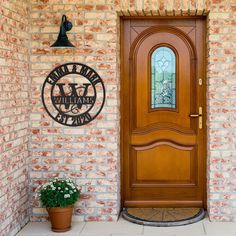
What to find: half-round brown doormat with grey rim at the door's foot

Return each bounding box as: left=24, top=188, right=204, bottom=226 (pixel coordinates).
left=122, top=208, right=205, bottom=227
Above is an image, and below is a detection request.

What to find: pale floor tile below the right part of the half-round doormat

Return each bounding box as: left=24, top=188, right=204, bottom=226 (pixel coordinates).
left=144, top=222, right=205, bottom=236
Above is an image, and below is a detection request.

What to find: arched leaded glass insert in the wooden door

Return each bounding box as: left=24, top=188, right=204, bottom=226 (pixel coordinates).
left=151, top=47, right=176, bottom=108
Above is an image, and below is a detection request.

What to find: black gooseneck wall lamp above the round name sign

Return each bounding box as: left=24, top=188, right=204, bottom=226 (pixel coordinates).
left=51, top=15, right=74, bottom=48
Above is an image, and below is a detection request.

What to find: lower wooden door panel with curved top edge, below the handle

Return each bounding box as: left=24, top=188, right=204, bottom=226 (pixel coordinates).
left=134, top=143, right=194, bottom=181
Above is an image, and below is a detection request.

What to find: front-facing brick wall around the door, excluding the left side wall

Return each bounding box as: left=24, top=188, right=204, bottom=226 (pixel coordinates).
left=30, top=0, right=236, bottom=221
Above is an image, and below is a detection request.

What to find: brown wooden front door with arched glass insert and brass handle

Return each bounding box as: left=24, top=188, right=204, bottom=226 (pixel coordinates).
left=121, top=18, right=206, bottom=207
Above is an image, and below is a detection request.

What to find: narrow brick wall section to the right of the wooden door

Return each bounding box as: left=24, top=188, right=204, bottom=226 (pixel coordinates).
left=207, top=0, right=236, bottom=221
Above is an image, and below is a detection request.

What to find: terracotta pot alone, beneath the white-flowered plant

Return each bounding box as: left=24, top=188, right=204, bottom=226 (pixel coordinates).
left=47, top=206, right=74, bottom=232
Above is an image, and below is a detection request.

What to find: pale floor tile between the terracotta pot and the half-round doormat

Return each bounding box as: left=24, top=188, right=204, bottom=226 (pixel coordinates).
left=81, top=219, right=143, bottom=235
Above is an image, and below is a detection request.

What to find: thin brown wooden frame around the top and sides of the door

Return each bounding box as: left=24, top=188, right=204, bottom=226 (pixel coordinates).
left=120, top=16, right=207, bottom=209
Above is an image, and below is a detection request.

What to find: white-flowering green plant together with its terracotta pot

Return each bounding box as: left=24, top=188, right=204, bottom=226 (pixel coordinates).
left=39, top=178, right=80, bottom=232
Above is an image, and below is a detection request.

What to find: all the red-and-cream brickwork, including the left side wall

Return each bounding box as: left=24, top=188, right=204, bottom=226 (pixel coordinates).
left=0, top=0, right=236, bottom=232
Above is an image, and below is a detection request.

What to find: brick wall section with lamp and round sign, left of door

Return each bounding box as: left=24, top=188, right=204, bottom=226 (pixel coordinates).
left=30, top=0, right=120, bottom=221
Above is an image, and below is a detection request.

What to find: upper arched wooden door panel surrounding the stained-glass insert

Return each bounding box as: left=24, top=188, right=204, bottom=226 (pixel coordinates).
left=134, top=28, right=196, bottom=128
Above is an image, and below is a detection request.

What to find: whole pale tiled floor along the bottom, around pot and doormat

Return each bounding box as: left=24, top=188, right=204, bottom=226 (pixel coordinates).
left=17, top=219, right=236, bottom=236
